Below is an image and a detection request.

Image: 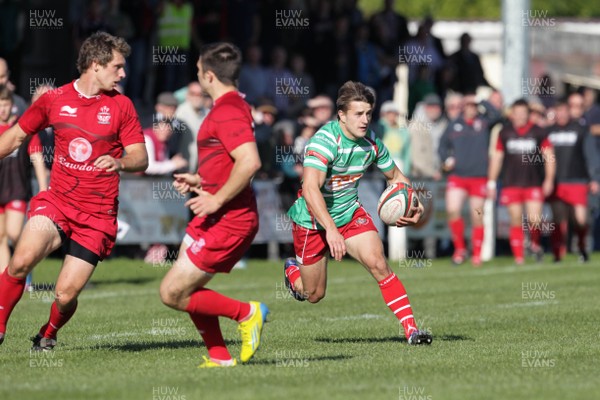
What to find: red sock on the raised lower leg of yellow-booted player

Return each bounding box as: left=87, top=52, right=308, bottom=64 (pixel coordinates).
left=186, top=288, right=251, bottom=322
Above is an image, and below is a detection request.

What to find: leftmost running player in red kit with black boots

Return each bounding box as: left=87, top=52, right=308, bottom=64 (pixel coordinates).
left=0, top=32, right=148, bottom=350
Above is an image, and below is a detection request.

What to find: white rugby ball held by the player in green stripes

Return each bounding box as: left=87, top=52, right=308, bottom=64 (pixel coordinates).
left=377, top=183, right=419, bottom=226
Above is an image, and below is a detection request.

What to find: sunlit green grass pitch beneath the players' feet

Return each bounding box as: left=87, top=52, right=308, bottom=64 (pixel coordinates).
left=0, top=254, right=600, bottom=400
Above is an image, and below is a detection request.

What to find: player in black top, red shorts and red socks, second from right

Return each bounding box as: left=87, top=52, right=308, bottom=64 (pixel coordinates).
left=487, top=100, right=556, bottom=265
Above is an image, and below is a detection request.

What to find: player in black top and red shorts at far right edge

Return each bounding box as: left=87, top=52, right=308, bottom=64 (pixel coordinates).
left=548, top=101, right=600, bottom=262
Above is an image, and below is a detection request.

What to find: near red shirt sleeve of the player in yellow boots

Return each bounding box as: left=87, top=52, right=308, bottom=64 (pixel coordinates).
left=213, top=106, right=255, bottom=153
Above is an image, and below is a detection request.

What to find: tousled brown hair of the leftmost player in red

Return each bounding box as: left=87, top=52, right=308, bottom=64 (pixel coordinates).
left=77, top=32, right=131, bottom=74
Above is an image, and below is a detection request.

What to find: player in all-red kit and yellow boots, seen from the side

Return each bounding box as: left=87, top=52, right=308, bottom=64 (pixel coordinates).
left=160, top=43, right=269, bottom=368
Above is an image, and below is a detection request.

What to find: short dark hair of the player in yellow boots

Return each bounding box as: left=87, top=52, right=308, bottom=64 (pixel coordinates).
left=200, top=42, right=242, bottom=86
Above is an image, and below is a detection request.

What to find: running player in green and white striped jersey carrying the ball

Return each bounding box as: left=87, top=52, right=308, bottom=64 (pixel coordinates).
left=284, top=81, right=432, bottom=344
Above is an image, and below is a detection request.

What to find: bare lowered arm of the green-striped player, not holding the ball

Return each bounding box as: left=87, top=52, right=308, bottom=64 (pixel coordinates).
left=302, top=166, right=346, bottom=261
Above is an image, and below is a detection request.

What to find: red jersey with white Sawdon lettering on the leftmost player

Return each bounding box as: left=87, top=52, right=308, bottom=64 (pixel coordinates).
left=18, top=82, right=144, bottom=215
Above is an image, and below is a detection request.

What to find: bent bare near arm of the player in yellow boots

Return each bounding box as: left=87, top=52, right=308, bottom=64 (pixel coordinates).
left=185, top=142, right=261, bottom=217
